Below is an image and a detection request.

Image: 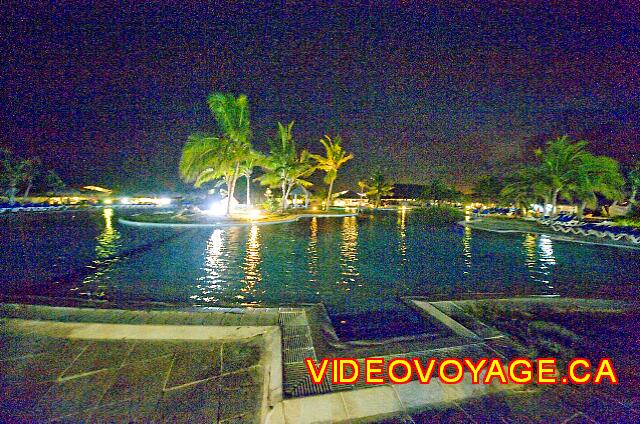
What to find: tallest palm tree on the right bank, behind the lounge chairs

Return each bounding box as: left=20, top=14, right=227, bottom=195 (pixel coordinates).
left=536, top=136, right=589, bottom=215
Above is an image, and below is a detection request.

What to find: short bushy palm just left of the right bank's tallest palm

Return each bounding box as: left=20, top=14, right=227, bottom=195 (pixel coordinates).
left=500, top=166, right=548, bottom=215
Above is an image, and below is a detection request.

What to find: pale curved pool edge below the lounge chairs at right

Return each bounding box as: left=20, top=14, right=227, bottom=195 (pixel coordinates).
left=458, top=218, right=640, bottom=250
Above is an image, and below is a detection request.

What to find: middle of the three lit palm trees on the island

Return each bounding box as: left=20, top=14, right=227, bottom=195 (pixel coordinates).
left=258, top=121, right=315, bottom=210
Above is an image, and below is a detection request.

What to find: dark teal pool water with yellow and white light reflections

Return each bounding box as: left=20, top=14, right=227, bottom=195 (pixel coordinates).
left=0, top=209, right=640, bottom=338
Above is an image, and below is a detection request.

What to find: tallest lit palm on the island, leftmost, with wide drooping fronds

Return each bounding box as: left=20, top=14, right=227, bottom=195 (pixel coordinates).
left=180, top=93, right=251, bottom=216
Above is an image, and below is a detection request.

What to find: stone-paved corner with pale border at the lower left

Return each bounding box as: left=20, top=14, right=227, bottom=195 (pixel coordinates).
left=0, top=305, right=281, bottom=423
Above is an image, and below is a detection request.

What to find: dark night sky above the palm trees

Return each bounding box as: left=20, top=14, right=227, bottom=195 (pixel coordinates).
left=0, top=1, right=640, bottom=189
